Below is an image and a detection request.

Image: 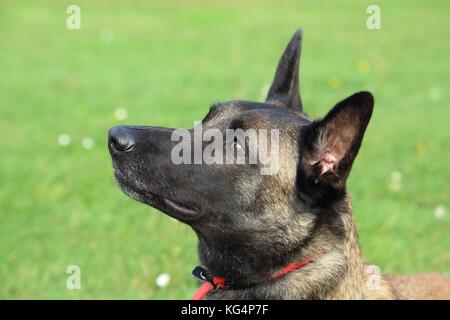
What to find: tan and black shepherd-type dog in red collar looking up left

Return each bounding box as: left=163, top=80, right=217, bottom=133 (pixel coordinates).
left=108, top=29, right=450, bottom=299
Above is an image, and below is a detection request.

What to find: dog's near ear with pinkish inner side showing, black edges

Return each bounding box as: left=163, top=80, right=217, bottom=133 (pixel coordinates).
left=301, top=92, right=374, bottom=189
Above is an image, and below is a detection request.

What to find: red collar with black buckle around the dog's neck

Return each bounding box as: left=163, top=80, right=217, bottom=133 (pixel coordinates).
left=192, top=249, right=325, bottom=300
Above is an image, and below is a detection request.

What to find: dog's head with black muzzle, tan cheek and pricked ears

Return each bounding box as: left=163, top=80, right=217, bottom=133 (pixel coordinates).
left=108, top=30, right=374, bottom=278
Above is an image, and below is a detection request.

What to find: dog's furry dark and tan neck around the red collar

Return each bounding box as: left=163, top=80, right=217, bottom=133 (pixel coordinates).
left=195, top=197, right=392, bottom=299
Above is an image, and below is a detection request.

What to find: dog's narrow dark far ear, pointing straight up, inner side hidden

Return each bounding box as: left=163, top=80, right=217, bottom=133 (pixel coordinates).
left=266, top=29, right=303, bottom=112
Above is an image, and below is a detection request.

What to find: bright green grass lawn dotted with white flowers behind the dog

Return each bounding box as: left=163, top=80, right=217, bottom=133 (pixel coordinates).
left=0, top=0, right=450, bottom=299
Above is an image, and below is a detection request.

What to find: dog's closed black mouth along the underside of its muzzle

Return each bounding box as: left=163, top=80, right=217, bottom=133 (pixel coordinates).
left=114, top=169, right=202, bottom=222
